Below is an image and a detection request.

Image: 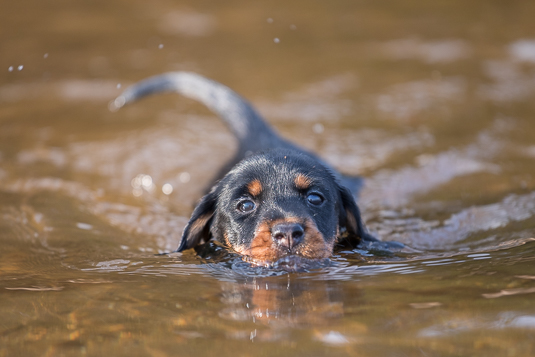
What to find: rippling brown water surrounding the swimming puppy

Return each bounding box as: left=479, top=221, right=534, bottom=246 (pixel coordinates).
left=0, top=0, right=535, bottom=357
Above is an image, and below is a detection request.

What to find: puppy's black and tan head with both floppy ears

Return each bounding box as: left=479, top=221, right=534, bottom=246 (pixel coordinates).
left=178, top=151, right=365, bottom=263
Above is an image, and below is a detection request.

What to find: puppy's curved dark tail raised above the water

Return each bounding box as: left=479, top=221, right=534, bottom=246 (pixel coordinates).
left=109, top=72, right=295, bottom=153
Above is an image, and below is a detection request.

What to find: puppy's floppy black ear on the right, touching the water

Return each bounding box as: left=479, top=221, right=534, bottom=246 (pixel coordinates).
left=338, top=186, right=377, bottom=247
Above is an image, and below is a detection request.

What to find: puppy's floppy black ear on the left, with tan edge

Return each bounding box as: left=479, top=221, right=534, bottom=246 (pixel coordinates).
left=176, top=185, right=221, bottom=252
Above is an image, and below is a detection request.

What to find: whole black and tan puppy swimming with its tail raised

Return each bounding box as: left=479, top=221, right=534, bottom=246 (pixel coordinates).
left=111, top=72, right=386, bottom=265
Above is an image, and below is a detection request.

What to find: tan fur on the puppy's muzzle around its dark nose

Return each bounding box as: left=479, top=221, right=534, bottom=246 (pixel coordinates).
left=239, top=217, right=336, bottom=262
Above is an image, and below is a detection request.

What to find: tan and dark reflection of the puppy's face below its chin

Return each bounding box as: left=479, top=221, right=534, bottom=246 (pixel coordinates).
left=219, top=275, right=352, bottom=341
